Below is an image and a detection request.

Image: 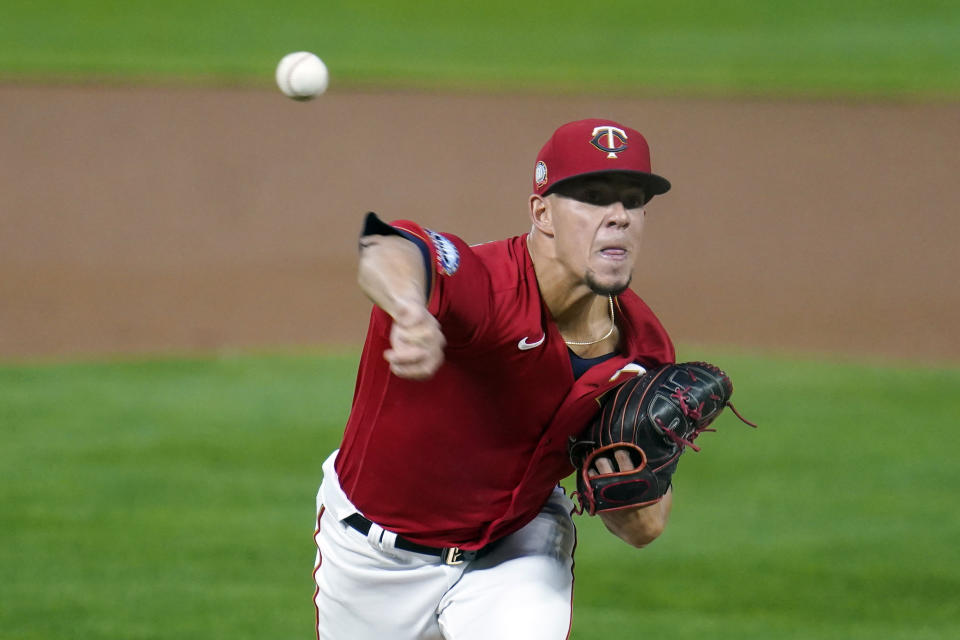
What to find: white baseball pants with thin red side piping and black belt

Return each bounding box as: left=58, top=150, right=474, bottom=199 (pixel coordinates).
left=314, top=452, right=576, bottom=640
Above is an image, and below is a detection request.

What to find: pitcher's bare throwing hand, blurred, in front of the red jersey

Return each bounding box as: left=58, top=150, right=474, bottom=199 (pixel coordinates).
left=383, top=301, right=447, bottom=380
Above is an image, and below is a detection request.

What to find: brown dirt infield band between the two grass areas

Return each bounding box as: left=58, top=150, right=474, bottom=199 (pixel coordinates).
left=0, top=86, right=960, bottom=362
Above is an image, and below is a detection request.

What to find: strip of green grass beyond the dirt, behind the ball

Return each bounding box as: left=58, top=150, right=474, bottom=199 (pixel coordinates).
left=0, top=0, right=960, bottom=98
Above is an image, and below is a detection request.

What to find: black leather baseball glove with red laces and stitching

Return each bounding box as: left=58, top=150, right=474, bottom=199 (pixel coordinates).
left=570, top=362, right=756, bottom=515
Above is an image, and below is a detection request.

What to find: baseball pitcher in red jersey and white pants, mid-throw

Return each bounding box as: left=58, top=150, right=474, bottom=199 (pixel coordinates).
left=314, top=120, right=748, bottom=640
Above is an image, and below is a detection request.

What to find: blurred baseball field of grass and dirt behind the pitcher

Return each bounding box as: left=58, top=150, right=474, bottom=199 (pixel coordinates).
left=0, top=0, right=960, bottom=639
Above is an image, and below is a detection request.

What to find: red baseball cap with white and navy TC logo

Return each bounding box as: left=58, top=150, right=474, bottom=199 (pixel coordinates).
left=533, top=118, right=670, bottom=200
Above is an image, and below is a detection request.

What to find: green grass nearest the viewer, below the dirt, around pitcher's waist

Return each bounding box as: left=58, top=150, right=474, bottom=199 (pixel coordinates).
left=0, top=350, right=960, bottom=640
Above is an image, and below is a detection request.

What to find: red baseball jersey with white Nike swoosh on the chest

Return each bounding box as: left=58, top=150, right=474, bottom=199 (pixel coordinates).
left=336, top=221, right=675, bottom=550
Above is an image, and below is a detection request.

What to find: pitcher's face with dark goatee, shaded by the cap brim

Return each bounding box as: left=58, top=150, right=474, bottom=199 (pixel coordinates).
left=549, top=174, right=646, bottom=295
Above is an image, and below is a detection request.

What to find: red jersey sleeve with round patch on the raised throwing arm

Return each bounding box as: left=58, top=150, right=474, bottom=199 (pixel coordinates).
left=364, top=214, right=492, bottom=347
